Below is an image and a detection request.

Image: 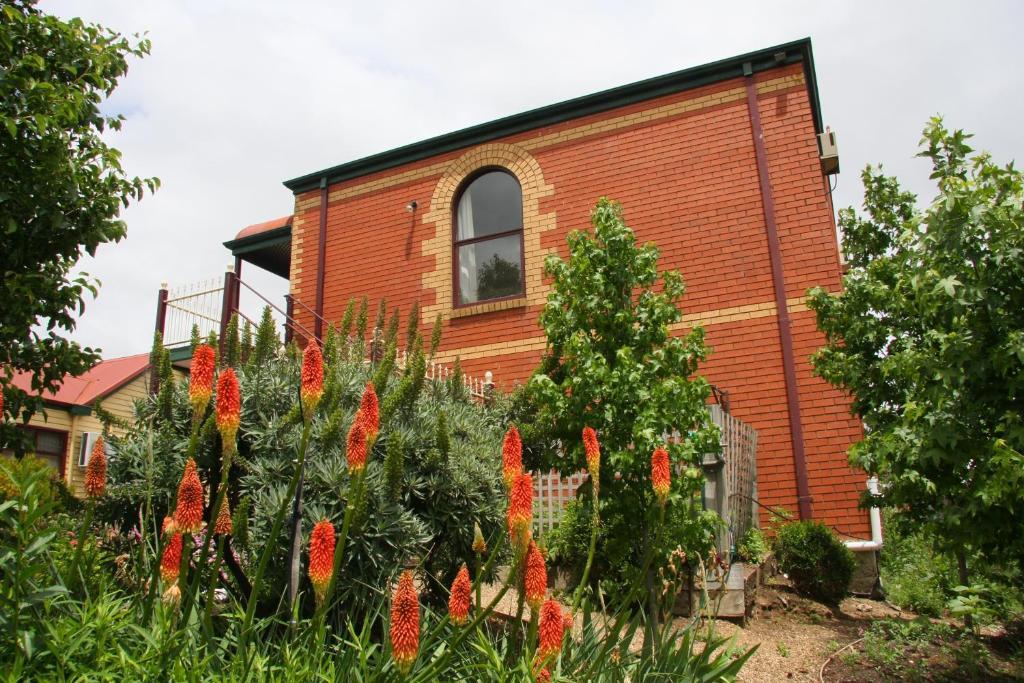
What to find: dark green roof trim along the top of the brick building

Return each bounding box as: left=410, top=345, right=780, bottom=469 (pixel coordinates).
left=282, top=38, right=824, bottom=194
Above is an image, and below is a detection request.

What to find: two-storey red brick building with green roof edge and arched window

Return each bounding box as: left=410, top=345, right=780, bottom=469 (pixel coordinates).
left=226, top=40, right=870, bottom=539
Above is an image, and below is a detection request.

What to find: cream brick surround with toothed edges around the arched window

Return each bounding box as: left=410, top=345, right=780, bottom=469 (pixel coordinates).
left=422, top=143, right=555, bottom=321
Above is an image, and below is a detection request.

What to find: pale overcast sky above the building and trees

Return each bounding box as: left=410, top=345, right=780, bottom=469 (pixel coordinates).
left=41, top=0, right=1024, bottom=357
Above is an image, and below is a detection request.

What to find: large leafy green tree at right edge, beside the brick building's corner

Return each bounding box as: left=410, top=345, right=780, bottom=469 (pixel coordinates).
left=810, top=119, right=1024, bottom=584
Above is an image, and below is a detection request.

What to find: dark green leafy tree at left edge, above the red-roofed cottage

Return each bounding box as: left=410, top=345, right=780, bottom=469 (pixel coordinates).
left=0, top=0, right=159, bottom=444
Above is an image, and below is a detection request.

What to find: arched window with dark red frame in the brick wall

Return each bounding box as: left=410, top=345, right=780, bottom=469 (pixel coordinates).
left=453, top=169, right=525, bottom=306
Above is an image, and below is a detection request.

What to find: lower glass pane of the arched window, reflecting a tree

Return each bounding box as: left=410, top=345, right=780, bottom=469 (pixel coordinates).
left=459, top=234, right=523, bottom=304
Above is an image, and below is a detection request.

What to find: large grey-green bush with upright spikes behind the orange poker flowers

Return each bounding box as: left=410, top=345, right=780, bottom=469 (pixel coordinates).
left=110, top=321, right=505, bottom=610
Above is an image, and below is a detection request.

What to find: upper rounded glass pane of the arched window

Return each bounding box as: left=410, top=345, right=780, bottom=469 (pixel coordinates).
left=458, top=171, right=522, bottom=241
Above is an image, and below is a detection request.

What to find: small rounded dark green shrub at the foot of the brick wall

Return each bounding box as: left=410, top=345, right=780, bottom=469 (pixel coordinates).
left=775, top=520, right=856, bottom=605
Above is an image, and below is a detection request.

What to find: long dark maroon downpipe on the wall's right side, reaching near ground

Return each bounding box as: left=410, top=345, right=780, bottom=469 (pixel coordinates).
left=743, top=62, right=814, bottom=519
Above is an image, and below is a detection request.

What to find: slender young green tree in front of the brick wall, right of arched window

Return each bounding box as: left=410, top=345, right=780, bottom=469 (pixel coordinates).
left=513, top=199, right=719, bottom=610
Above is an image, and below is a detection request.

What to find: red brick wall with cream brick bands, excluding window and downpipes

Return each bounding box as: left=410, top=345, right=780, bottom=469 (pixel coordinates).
left=292, top=65, right=869, bottom=538
